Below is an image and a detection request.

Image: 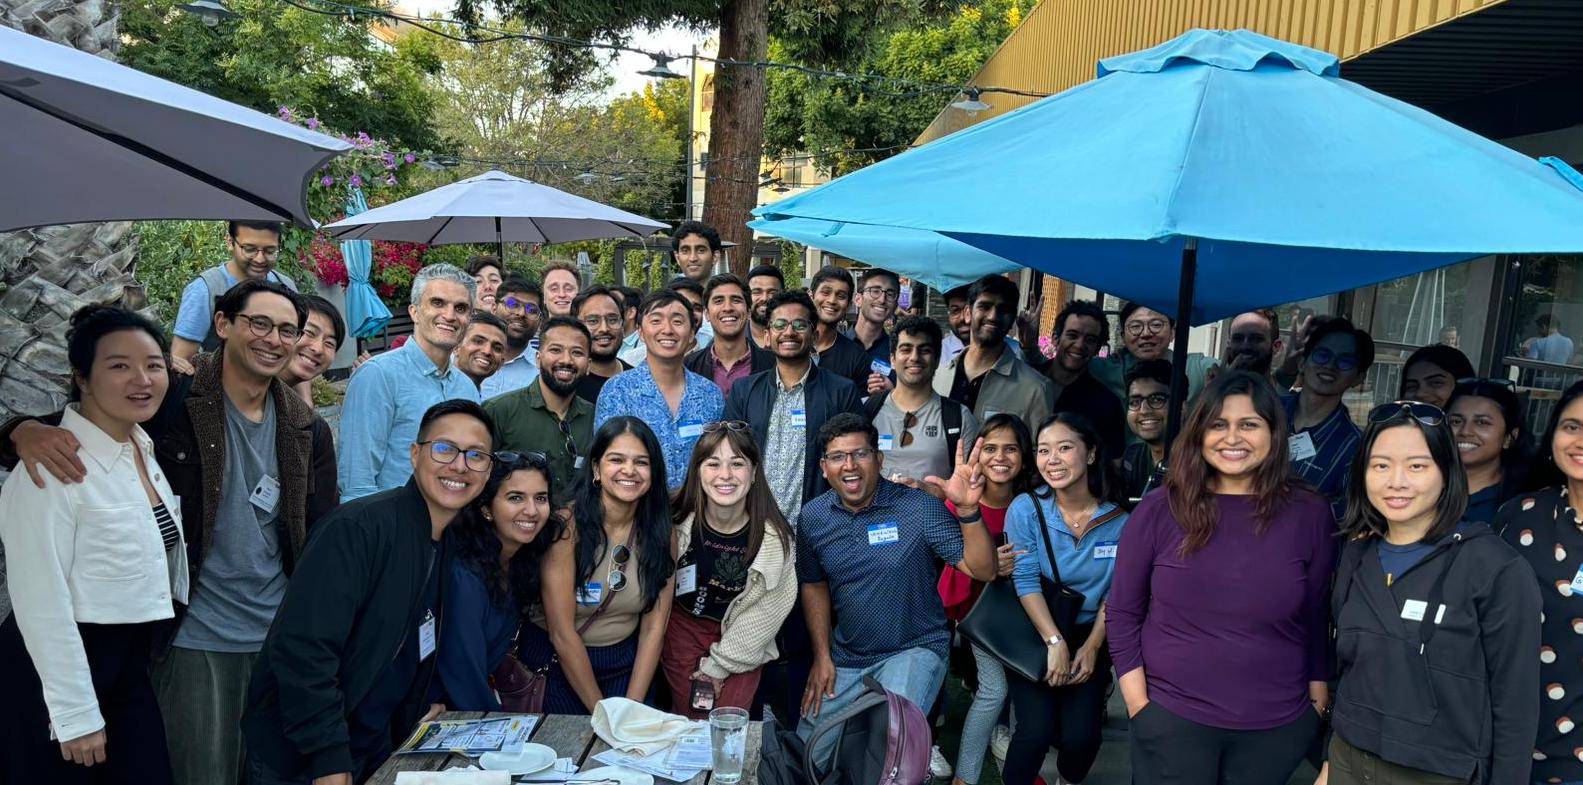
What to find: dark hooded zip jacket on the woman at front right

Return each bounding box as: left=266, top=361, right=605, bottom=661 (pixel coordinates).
left=1331, top=522, right=1540, bottom=785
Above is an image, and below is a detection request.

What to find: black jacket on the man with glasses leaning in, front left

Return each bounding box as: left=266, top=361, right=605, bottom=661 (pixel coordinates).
left=242, top=480, right=450, bottom=779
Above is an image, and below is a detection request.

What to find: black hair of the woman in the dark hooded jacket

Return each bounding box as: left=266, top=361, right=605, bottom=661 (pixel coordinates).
left=1342, top=411, right=1467, bottom=544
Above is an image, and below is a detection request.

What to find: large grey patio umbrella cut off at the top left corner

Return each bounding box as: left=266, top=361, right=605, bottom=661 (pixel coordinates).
left=0, top=27, right=351, bottom=231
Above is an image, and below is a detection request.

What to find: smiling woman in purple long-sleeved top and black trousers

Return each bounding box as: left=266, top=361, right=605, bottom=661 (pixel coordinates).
left=1105, top=372, right=1338, bottom=785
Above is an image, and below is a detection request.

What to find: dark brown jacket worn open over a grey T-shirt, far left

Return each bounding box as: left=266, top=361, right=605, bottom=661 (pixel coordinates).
left=0, top=353, right=340, bottom=658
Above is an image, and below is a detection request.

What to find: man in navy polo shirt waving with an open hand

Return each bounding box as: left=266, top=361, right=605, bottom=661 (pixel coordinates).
left=796, top=413, right=996, bottom=747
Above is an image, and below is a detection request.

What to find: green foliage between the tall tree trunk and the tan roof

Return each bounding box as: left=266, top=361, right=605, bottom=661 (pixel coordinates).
left=765, top=0, right=1034, bottom=176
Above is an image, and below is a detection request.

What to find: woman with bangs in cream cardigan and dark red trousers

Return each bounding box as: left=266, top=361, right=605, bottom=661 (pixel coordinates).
left=660, top=421, right=798, bottom=719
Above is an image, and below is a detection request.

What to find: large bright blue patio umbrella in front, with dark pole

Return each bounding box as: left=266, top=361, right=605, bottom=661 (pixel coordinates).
left=755, top=30, right=1583, bottom=432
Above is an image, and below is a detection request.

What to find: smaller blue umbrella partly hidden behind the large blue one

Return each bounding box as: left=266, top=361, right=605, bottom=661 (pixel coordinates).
left=747, top=218, right=1021, bottom=291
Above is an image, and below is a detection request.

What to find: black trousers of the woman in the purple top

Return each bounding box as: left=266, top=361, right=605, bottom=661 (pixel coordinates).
left=1127, top=693, right=1320, bottom=785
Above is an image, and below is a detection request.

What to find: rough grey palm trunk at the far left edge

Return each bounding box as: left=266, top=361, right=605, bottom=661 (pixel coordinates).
left=0, top=0, right=138, bottom=619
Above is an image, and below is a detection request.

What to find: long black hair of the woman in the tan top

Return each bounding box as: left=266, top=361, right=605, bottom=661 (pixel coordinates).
left=571, top=415, right=676, bottom=612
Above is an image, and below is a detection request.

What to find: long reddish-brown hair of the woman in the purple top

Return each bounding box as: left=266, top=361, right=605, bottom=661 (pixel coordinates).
left=1165, top=370, right=1298, bottom=557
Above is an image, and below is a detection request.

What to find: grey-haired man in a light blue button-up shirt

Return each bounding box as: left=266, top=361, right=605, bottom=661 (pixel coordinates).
left=336, top=264, right=478, bottom=502
